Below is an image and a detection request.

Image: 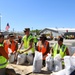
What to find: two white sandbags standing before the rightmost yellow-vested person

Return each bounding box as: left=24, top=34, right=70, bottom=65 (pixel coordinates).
left=46, top=54, right=62, bottom=72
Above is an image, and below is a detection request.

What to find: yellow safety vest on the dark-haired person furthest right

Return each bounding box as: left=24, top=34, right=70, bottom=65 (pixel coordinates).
left=53, top=44, right=66, bottom=58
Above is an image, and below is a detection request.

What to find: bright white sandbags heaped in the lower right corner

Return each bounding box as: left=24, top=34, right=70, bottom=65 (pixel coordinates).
left=52, top=56, right=75, bottom=75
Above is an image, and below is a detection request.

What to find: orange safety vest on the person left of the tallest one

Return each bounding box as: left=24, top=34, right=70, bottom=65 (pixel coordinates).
left=4, top=40, right=17, bottom=53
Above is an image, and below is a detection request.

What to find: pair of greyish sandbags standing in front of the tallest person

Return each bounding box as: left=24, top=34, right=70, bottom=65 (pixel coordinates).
left=17, top=50, right=33, bottom=64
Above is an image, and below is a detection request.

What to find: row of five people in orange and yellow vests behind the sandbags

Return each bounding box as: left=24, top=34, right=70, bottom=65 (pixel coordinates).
left=0, top=28, right=75, bottom=75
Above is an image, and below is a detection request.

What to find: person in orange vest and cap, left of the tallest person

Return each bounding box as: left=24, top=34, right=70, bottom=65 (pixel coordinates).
left=4, top=33, right=18, bottom=62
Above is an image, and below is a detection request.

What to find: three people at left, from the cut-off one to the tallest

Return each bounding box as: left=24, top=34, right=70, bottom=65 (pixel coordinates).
left=0, top=28, right=35, bottom=75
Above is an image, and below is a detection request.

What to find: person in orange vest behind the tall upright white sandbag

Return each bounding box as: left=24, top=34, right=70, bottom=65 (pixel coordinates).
left=36, top=34, right=50, bottom=66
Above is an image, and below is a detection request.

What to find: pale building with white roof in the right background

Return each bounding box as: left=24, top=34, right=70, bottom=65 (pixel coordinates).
left=40, top=27, right=75, bottom=38
